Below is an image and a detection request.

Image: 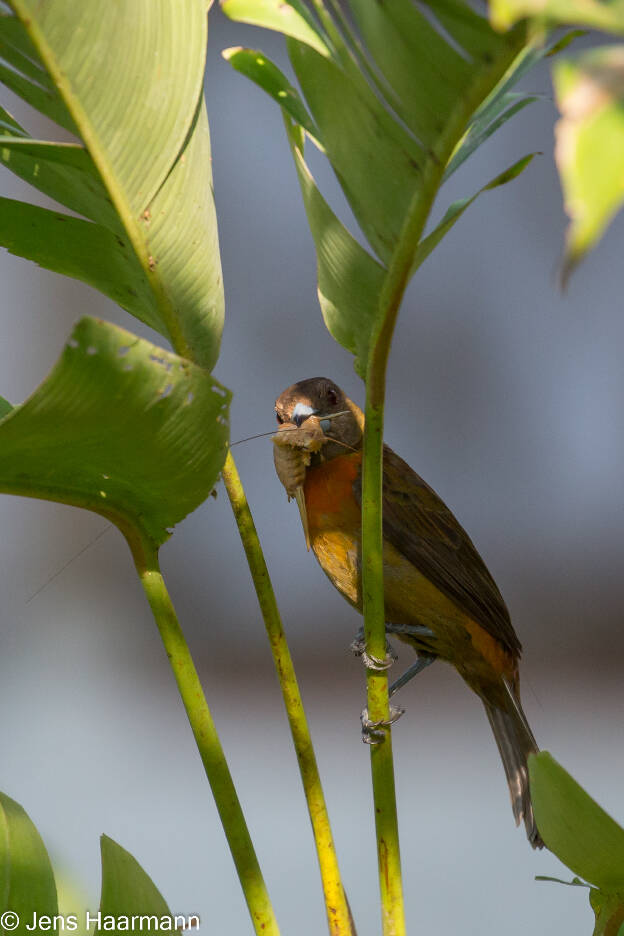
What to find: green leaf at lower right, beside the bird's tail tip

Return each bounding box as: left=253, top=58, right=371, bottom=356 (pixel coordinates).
left=529, top=751, right=624, bottom=891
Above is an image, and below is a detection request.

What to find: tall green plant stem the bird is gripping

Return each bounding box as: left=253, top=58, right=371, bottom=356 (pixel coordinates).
left=362, top=28, right=525, bottom=936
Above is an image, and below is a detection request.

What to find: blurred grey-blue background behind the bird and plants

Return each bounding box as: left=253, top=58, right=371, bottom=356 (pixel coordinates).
left=0, top=9, right=624, bottom=936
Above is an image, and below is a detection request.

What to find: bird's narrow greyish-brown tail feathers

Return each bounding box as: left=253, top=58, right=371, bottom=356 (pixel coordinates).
left=483, top=682, right=544, bottom=848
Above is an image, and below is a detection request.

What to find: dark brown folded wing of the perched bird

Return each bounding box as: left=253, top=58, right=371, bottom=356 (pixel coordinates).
left=354, top=445, right=521, bottom=656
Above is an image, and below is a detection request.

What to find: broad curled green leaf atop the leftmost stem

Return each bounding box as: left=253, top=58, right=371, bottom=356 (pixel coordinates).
left=0, top=318, right=230, bottom=545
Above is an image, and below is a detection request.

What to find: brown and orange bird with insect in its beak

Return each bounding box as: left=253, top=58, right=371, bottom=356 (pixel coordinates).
left=273, top=377, right=543, bottom=848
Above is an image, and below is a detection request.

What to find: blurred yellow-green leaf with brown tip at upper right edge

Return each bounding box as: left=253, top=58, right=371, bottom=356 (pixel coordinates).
left=553, top=46, right=624, bottom=278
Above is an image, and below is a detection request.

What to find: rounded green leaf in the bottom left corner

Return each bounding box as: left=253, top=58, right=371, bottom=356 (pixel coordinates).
left=0, top=793, right=58, bottom=936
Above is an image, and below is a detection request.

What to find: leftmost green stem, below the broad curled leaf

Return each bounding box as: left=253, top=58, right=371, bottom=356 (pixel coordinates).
left=130, top=541, right=279, bottom=936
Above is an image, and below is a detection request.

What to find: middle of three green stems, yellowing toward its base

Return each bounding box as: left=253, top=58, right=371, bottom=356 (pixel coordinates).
left=222, top=452, right=355, bottom=936
